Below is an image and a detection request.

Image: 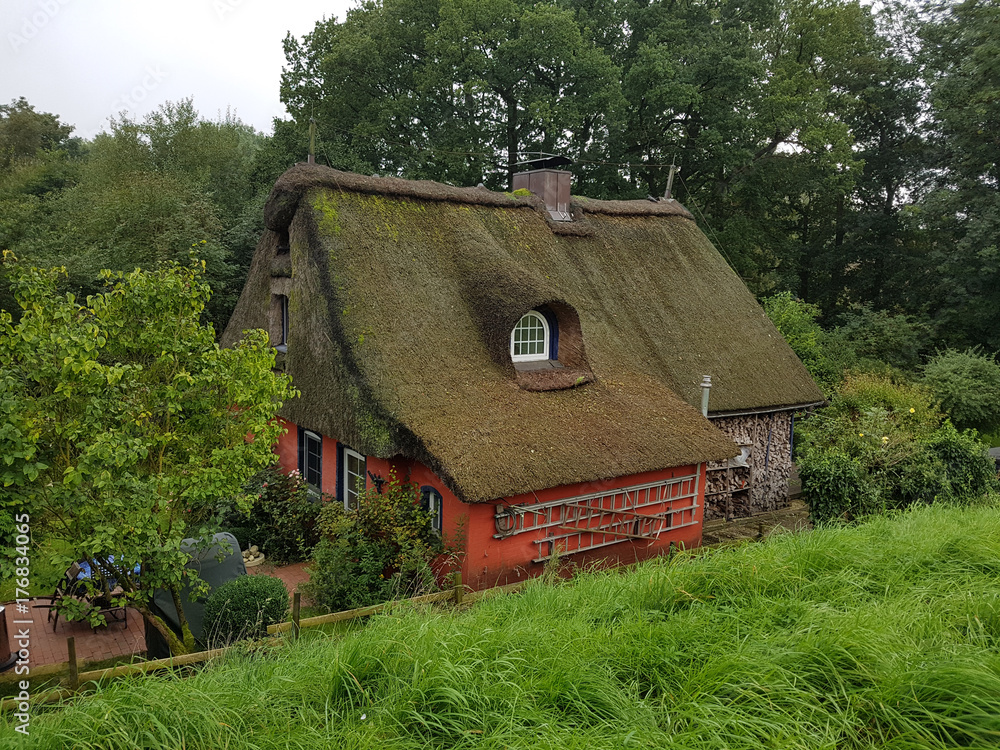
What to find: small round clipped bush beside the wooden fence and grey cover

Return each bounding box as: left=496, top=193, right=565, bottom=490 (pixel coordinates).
left=204, top=575, right=288, bottom=647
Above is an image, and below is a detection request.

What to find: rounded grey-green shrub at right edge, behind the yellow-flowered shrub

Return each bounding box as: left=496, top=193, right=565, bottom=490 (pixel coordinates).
left=923, top=347, right=1000, bottom=432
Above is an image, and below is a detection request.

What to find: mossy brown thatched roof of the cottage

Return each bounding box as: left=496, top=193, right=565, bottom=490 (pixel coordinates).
left=223, top=166, right=822, bottom=502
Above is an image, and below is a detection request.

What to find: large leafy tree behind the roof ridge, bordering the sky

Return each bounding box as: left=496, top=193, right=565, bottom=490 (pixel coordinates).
left=281, top=0, right=623, bottom=187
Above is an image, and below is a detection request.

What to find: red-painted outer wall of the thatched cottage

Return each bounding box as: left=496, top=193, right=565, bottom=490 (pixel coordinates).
left=276, top=420, right=705, bottom=589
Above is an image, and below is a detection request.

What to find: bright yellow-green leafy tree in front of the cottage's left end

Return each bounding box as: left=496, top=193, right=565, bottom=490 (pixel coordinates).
left=0, top=254, right=296, bottom=653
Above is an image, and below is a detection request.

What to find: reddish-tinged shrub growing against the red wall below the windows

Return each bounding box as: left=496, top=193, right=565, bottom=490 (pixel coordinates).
left=303, top=475, right=443, bottom=612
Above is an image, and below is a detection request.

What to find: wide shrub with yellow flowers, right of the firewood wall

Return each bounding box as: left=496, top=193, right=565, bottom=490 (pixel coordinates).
left=797, top=373, right=997, bottom=521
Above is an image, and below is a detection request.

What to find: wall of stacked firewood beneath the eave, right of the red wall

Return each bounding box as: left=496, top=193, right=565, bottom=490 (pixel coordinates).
left=705, top=411, right=794, bottom=520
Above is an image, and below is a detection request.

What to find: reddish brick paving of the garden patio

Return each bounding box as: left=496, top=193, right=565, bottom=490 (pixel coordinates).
left=3, top=561, right=309, bottom=667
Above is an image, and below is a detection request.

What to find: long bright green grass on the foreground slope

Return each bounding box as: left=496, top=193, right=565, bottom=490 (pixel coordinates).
left=8, top=506, right=1000, bottom=750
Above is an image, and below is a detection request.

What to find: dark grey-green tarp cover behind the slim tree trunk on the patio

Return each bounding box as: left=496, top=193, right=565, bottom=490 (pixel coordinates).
left=146, top=532, right=247, bottom=659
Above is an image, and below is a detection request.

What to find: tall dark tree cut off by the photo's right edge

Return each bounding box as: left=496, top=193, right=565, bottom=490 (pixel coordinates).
left=920, top=0, right=1000, bottom=350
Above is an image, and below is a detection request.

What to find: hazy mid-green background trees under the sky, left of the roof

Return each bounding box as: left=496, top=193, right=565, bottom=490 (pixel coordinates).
left=0, top=99, right=270, bottom=328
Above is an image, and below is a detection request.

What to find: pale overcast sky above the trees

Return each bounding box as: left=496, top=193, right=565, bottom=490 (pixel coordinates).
left=0, top=0, right=358, bottom=138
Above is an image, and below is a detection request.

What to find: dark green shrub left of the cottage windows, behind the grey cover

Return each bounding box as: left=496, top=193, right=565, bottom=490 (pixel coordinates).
left=220, top=466, right=320, bottom=564
